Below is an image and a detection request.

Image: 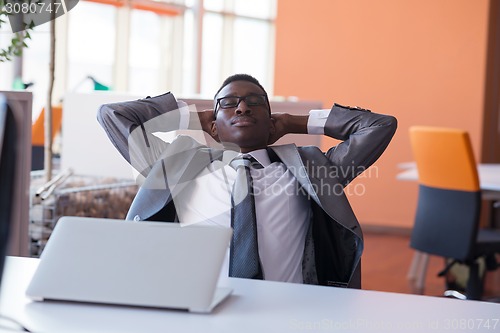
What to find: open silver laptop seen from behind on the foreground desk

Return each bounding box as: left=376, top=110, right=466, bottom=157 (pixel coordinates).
left=26, top=216, right=232, bottom=313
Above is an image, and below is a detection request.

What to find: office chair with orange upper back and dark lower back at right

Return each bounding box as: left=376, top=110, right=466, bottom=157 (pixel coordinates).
left=410, top=126, right=500, bottom=300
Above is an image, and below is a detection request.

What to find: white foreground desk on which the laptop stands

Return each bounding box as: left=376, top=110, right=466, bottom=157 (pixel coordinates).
left=0, top=257, right=500, bottom=333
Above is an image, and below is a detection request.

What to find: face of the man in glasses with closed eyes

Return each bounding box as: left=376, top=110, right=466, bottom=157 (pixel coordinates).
left=212, top=81, right=275, bottom=153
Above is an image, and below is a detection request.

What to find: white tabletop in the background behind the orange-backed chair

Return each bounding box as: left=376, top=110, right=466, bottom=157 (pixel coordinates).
left=396, top=162, right=500, bottom=192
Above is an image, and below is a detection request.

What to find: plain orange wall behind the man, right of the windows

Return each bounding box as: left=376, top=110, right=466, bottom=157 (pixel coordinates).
left=274, top=0, right=489, bottom=227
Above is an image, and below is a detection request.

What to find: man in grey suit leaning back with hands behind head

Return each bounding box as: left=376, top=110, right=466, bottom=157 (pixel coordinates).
left=98, top=74, right=397, bottom=288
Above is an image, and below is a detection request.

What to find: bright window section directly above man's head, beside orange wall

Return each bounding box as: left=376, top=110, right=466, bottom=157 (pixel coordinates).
left=200, top=0, right=276, bottom=97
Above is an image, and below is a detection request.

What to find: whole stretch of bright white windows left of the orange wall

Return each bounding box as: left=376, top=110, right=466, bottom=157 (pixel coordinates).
left=0, top=0, right=276, bottom=105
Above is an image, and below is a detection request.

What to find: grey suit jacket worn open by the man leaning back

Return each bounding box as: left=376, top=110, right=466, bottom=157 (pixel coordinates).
left=97, top=93, right=397, bottom=288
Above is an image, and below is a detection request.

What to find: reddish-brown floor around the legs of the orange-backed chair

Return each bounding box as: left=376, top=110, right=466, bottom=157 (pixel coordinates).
left=362, top=232, right=500, bottom=297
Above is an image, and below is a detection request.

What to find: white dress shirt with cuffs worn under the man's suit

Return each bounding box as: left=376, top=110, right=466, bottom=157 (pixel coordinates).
left=173, top=110, right=330, bottom=283
